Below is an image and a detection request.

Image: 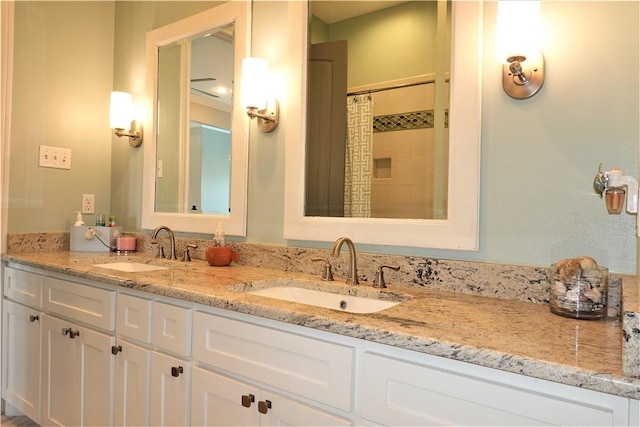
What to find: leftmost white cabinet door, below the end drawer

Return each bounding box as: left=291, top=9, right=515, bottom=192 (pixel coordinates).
left=2, top=300, right=42, bottom=424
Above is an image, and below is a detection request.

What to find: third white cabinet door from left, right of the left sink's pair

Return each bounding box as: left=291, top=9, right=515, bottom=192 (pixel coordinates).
left=75, top=326, right=116, bottom=426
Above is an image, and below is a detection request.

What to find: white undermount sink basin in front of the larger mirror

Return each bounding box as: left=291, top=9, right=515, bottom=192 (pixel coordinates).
left=247, top=286, right=400, bottom=313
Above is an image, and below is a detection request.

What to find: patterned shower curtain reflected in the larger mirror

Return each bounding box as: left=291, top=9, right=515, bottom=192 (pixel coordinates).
left=344, top=94, right=373, bottom=218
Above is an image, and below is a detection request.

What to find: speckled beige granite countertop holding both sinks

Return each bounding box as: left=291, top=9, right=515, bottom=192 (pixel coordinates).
left=3, top=252, right=640, bottom=399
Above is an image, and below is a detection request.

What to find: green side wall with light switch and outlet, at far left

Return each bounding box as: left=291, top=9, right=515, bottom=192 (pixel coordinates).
left=8, top=1, right=115, bottom=232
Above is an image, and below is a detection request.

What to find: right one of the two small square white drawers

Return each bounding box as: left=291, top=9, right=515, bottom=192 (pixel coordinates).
left=151, top=301, right=192, bottom=356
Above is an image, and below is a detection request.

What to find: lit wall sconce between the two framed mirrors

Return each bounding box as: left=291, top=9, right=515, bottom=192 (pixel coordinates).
left=240, top=57, right=280, bottom=133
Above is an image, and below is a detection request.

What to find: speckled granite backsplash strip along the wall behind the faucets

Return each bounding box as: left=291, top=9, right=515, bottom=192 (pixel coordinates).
left=8, top=232, right=640, bottom=377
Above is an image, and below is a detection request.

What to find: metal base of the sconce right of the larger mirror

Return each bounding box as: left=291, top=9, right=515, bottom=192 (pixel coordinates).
left=502, top=53, right=544, bottom=99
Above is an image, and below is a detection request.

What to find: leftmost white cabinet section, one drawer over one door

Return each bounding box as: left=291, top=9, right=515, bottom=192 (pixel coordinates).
left=2, top=268, right=42, bottom=424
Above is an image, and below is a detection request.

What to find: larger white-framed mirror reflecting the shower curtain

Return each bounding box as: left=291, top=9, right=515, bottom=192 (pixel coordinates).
left=284, top=0, right=483, bottom=250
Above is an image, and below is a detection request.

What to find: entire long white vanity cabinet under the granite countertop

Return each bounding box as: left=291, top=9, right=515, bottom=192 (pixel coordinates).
left=2, top=264, right=640, bottom=426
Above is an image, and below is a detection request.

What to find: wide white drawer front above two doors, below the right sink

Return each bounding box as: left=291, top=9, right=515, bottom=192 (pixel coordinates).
left=193, top=312, right=354, bottom=411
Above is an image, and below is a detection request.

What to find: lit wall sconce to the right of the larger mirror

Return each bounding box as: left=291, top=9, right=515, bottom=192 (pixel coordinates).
left=496, top=0, right=544, bottom=99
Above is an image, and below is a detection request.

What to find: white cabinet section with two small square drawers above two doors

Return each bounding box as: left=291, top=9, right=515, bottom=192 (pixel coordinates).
left=114, top=293, right=192, bottom=426
